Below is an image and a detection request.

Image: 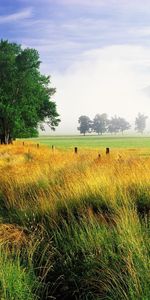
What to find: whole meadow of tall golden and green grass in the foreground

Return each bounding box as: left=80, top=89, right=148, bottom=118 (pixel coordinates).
left=0, top=141, right=150, bottom=300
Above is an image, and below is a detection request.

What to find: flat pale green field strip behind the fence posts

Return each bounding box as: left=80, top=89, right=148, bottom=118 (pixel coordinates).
left=28, top=136, right=150, bottom=149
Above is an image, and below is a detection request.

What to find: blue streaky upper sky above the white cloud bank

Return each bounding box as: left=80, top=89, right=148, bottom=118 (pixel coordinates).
left=0, top=0, right=150, bottom=72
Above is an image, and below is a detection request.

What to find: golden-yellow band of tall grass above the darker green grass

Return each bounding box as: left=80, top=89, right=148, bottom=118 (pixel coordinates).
left=0, top=143, right=150, bottom=212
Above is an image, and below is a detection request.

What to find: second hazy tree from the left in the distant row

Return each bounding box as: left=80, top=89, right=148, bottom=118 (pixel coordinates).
left=92, top=113, right=108, bottom=135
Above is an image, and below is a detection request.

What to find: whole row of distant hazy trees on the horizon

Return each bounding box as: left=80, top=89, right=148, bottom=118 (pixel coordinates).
left=77, top=113, right=148, bottom=135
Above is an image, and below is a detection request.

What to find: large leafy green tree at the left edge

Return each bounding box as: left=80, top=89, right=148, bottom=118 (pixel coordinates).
left=0, top=40, right=60, bottom=143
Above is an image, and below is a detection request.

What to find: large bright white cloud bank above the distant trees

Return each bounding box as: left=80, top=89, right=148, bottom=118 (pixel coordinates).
left=47, top=45, right=150, bottom=133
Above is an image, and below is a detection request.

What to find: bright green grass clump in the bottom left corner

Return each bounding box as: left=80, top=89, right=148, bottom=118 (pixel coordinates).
left=0, top=247, right=37, bottom=300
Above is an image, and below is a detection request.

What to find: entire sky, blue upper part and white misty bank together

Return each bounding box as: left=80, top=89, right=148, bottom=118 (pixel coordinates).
left=0, top=0, right=150, bottom=134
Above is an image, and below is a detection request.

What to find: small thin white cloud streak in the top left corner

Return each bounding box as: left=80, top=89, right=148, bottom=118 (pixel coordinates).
left=0, top=8, right=32, bottom=24
